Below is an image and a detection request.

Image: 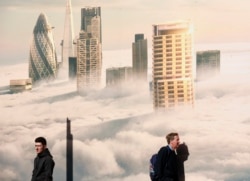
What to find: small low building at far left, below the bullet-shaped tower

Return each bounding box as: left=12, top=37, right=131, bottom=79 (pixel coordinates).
left=10, top=79, right=32, bottom=93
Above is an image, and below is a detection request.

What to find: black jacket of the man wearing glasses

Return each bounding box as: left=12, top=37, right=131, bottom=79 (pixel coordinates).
left=31, top=148, right=55, bottom=181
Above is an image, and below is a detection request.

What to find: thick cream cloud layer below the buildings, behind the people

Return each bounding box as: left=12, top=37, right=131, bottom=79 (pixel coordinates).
left=0, top=46, right=250, bottom=181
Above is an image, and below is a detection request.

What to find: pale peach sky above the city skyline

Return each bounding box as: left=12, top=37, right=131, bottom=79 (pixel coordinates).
left=0, top=0, right=250, bottom=65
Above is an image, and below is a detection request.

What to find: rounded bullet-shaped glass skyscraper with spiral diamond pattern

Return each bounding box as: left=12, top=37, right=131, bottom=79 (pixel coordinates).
left=29, top=13, right=57, bottom=83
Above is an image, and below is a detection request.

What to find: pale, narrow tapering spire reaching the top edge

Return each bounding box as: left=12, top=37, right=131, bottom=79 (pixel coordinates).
left=62, top=0, right=75, bottom=76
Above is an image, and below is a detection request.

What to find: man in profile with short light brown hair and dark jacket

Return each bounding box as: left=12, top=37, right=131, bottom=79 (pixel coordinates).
left=156, top=133, right=179, bottom=181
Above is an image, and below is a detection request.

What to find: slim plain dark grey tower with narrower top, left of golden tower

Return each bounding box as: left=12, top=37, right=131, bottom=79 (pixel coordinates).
left=132, top=34, right=148, bottom=81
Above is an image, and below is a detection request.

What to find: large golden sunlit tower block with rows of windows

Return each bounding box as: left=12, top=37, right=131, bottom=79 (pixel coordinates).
left=153, top=21, right=194, bottom=109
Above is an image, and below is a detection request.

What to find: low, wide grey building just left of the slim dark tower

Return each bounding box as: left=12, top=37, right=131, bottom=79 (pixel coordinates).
left=106, top=67, right=132, bottom=86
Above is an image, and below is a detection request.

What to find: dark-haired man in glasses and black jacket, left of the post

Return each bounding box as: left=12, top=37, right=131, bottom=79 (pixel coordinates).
left=31, top=137, right=55, bottom=181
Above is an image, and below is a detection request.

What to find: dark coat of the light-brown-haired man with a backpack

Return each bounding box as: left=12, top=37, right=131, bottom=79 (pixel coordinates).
left=156, top=146, right=178, bottom=181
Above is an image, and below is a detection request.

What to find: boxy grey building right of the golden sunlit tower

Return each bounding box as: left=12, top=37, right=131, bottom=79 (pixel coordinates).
left=196, top=50, right=220, bottom=80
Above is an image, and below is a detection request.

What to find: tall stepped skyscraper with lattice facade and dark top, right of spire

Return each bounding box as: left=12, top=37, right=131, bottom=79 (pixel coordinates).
left=77, top=7, right=102, bottom=93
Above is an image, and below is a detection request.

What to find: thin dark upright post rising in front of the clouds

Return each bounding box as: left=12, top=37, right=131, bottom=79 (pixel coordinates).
left=66, top=118, right=73, bottom=181
